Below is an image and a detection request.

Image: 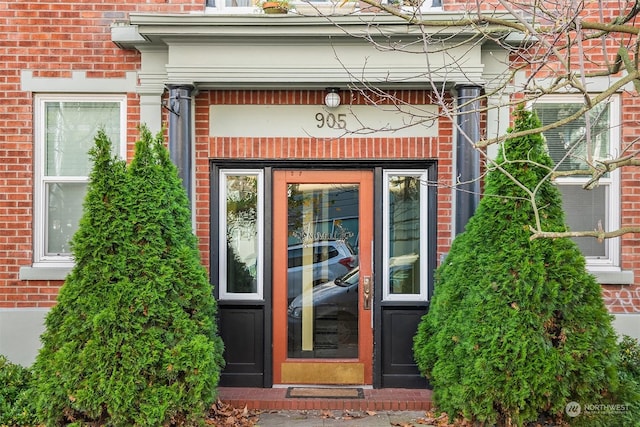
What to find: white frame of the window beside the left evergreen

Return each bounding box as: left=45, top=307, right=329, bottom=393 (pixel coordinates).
left=33, top=94, right=127, bottom=267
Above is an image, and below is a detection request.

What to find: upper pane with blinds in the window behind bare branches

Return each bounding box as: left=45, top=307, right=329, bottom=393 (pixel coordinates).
left=534, top=102, right=610, bottom=171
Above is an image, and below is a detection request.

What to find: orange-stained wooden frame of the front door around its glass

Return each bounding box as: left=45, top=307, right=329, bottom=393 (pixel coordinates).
left=272, top=170, right=374, bottom=385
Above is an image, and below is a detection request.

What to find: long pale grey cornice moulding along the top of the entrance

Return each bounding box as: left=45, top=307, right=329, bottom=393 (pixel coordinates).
left=112, top=12, right=515, bottom=49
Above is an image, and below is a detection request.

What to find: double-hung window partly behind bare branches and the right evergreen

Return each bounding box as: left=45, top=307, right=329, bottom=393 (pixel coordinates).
left=533, top=95, right=621, bottom=270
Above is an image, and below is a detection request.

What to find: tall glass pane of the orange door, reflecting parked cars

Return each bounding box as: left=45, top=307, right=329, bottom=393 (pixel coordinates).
left=287, top=184, right=359, bottom=358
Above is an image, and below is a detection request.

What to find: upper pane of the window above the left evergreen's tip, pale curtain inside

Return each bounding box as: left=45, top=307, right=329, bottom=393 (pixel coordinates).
left=44, top=101, right=120, bottom=176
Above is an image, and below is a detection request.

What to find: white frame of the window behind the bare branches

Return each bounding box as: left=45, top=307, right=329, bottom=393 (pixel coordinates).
left=530, top=94, right=622, bottom=272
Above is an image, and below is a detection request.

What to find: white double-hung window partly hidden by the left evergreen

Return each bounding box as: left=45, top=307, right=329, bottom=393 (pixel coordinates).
left=34, top=95, right=126, bottom=266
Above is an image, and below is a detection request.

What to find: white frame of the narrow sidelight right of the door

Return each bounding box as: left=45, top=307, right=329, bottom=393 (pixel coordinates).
left=382, top=169, right=429, bottom=301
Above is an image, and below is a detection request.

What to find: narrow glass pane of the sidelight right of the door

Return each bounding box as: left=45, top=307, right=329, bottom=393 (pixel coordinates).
left=387, top=176, right=421, bottom=294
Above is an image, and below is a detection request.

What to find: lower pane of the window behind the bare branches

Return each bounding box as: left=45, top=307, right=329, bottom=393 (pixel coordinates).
left=558, top=184, right=608, bottom=258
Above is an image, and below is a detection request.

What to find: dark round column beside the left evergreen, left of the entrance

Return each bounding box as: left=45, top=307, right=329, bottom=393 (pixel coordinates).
left=168, top=85, right=194, bottom=205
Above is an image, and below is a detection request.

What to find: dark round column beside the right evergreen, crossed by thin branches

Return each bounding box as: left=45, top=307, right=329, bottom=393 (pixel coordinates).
left=455, top=86, right=482, bottom=235
